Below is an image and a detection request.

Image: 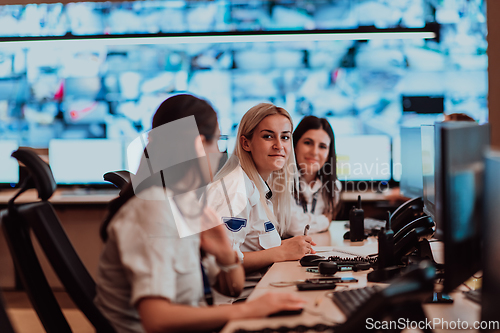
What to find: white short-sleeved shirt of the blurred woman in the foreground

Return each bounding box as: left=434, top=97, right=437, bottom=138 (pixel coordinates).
left=95, top=187, right=218, bottom=333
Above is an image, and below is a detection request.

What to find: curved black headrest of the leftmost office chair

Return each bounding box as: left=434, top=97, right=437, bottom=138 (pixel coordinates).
left=12, top=148, right=57, bottom=201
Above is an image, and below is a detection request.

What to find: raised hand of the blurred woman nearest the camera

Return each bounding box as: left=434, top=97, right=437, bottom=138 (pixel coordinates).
left=200, top=207, right=235, bottom=265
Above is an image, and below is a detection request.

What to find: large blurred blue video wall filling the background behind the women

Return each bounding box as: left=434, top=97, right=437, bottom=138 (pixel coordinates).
left=0, top=0, right=488, bottom=180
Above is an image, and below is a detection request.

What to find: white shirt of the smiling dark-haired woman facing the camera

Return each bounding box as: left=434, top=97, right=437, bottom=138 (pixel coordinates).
left=287, top=179, right=341, bottom=236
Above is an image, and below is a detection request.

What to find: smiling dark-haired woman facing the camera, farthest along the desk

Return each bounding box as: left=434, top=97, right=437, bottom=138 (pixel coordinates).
left=288, top=116, right=341, bottom=236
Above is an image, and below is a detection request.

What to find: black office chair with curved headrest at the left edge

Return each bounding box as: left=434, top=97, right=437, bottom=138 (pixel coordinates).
left=0, top=148, right=114, bottom=333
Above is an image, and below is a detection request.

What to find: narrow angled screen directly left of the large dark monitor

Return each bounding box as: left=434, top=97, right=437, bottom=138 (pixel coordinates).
left=420, top=125, right=437, bottom=223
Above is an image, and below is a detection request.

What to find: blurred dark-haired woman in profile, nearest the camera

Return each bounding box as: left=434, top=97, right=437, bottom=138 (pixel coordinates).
left=95, top=95, right=303, bottom=332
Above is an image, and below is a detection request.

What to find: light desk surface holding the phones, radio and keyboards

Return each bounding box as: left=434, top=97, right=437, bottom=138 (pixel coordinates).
left=222, top=222, right=480, bottom=333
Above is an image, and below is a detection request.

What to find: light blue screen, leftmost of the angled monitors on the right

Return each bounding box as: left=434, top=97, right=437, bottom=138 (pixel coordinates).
left=399, top=127, right=423, bottom=198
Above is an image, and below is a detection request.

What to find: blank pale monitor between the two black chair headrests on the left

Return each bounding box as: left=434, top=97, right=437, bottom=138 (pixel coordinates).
left=49, top=139, right=123, bottom=184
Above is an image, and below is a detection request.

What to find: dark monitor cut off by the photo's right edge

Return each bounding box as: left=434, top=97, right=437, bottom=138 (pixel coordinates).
left=481, top=151, right=500, bottom=322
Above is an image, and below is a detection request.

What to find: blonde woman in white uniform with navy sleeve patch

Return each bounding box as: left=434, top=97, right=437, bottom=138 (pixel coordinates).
left=208, top=103, right=316, bottom=273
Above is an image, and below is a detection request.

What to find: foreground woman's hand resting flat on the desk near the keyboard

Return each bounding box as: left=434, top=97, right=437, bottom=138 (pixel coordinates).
left=241, top=293, right=306, bottom=318
